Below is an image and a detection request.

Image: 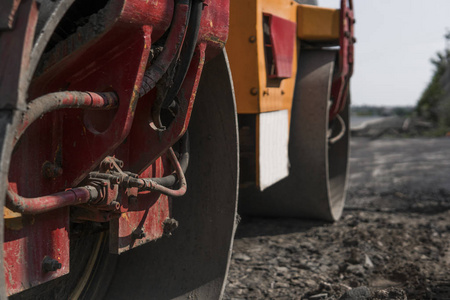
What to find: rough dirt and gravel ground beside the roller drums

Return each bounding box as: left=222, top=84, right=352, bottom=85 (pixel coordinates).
left=224, top=138, right=450, bottom=299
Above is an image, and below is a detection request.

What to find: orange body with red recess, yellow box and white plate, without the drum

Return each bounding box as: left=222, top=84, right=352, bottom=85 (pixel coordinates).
left=226, top=0, right=340, bottom=189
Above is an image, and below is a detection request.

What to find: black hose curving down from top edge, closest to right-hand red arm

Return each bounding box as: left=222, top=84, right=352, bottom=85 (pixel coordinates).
left=152, top=0, right=203, bottom=129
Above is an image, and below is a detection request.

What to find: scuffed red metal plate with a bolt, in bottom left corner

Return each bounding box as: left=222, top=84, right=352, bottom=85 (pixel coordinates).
left=3, top=207, right=70, bottom=295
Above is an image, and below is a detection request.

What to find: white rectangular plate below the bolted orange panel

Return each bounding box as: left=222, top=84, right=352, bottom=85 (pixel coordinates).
left=259, top=110, right=289, bottom=190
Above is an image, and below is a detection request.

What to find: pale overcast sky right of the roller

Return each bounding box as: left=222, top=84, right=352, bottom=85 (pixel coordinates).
left=319, top=0, right=450, bottom=106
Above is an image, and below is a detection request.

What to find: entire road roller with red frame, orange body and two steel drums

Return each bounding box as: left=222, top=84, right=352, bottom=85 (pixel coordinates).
left=0, top=0, right=354, bottom=299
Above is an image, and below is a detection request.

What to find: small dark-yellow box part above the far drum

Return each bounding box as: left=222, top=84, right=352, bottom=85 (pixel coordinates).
left=297, top=5, right=340, bottom=41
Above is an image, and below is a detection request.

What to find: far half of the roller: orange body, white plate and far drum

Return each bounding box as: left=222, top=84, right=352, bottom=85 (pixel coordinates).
left=232, top=0, right=356, bottom=221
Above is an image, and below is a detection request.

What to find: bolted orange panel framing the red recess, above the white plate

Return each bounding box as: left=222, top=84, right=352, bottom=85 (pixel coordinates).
left=226, top=0, right=298, bottom=114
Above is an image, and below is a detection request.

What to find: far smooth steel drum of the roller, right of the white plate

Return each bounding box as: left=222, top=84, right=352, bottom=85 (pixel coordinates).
left=240, top=50, right=349, bottom=221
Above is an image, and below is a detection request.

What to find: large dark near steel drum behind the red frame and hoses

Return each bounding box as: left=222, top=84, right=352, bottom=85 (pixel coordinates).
left=97, top=51, right=238, bottom=299
